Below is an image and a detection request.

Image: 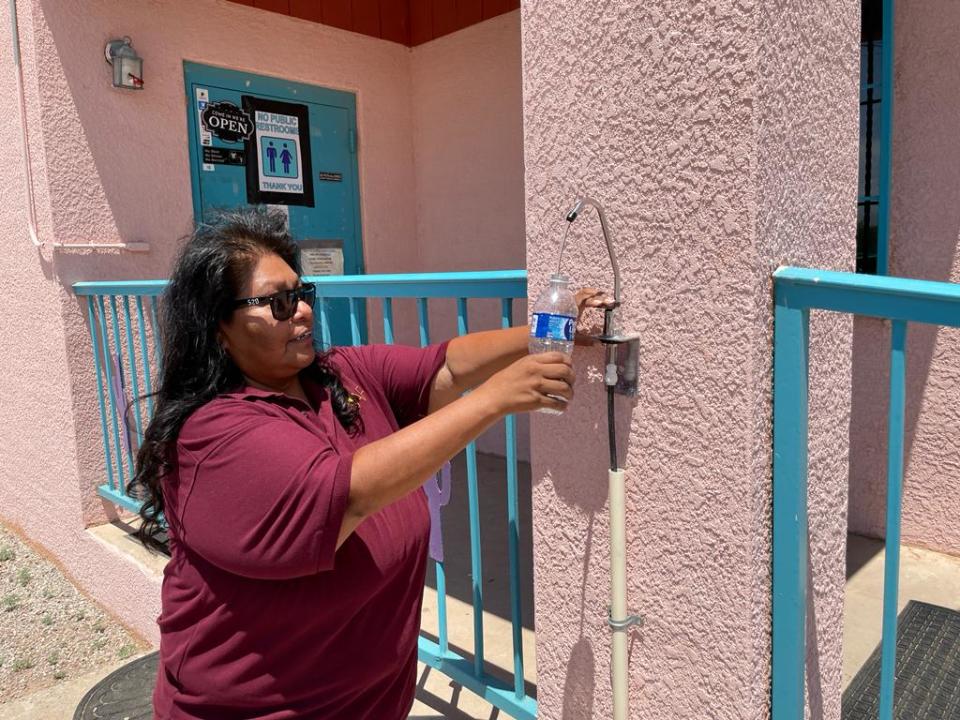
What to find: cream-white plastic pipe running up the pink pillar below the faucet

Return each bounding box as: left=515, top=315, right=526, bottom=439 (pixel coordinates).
left=607, top=469, right=629, bottom=720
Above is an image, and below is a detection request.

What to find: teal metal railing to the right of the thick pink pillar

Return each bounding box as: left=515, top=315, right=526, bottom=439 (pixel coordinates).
left=772, top=268, right=960, bottom=720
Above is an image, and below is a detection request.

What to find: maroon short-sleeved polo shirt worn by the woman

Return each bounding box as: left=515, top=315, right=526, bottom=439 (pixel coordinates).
left=154, top=344, right=446, bottom=720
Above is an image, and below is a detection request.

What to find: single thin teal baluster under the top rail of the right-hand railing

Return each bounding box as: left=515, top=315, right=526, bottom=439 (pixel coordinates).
left=879, top=320, right=907, bottom=720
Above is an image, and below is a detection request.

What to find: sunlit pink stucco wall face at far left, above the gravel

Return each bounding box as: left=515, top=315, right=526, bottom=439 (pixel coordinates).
left=0, top=2, right=159, bottom=637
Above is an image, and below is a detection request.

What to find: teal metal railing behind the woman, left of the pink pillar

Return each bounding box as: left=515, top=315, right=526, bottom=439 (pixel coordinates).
left=73, top=270, right=537, bottom=720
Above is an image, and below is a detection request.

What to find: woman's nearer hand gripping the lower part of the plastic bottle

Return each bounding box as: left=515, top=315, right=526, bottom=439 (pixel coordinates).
left=474, top=352, right=575, bottom=415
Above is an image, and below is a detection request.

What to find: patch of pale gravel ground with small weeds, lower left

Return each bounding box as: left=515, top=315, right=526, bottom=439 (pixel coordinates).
left=0, top=525, right=148, bottom=703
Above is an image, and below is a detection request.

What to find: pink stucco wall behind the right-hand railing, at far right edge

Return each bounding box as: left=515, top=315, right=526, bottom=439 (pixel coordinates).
left=850, top=0, right=960, bottom=555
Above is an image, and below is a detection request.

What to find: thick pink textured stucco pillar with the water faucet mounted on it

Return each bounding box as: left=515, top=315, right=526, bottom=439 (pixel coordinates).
left=522, top=0, right=859, bottom=720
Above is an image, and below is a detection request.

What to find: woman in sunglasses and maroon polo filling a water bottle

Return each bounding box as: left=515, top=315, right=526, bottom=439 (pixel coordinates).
left=135, top=205, right=603, bottom=720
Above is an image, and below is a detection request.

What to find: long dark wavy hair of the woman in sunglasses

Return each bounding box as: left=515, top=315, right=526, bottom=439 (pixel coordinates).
left=130, top=208, right=360, bottom=550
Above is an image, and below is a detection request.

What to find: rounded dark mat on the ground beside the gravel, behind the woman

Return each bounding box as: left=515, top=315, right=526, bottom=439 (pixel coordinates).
left=73, top=653, right=157, bottom=720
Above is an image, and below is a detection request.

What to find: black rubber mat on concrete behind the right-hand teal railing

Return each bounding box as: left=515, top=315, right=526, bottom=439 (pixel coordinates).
left=841, top=600, right=960, bottom=720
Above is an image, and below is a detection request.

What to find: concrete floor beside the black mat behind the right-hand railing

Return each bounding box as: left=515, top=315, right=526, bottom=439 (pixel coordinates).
left=843, top=535, right=960, bottom=689
